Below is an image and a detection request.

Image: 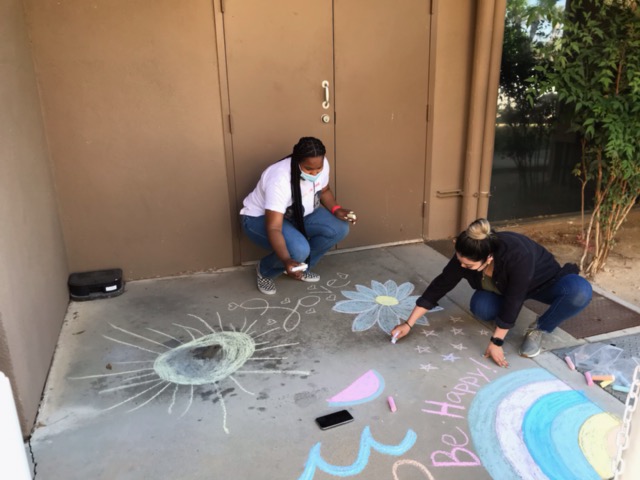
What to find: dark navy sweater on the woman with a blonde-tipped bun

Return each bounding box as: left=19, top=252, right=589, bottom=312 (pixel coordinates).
left=416, top=232, right=577, bottom=328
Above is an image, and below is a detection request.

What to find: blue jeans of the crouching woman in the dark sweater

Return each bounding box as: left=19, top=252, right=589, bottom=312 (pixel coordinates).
left=470, top=274, right=592, bottom=333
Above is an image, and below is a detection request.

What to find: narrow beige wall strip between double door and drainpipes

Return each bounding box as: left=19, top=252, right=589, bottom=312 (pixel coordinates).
left=425, top=0, right=476, bottom=239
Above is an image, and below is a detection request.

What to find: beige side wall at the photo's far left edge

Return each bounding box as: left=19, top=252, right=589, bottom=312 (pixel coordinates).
left=0, top=0, right=69, bottom=435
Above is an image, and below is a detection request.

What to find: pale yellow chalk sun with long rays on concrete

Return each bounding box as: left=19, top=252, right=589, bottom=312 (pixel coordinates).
left=71, top=314, right=310, bottom=434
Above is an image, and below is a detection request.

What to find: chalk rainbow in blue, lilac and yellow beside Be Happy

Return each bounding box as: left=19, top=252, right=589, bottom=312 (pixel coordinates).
left=468, top=368, right=620, bottom=480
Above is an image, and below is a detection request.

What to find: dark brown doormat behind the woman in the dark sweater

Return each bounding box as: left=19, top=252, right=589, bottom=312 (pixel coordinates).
left=426, top=239, right=640, bottom=338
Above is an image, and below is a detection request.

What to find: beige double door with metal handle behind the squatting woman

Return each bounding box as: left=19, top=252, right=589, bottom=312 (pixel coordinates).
left=223, top=0, right=430, bottom=261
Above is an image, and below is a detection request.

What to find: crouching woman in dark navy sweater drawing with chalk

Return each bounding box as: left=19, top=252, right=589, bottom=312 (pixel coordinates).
left=391, top=218, right=592, bottom=367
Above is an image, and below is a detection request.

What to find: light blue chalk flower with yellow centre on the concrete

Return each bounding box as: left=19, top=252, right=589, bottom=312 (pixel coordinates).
left=333, top=280, right=429, bottom=334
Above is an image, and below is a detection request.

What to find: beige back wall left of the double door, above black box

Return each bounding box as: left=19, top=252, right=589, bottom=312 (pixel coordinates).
left=25, top=0, right=236, bottom=279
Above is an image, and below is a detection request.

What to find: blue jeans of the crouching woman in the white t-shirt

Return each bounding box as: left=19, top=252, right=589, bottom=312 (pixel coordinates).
left=240, top=207, right=349, bottom=278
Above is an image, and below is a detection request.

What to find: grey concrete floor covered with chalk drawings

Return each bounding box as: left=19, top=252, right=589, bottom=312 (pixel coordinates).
left=31, top=244, right=624, bottom=480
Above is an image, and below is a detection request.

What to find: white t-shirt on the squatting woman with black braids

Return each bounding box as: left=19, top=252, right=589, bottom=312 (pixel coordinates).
left=240, top=157, right=329, bottom=217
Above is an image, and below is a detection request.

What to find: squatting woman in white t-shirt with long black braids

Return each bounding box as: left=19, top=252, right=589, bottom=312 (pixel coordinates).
left=240, top=137, right=356, bottom=295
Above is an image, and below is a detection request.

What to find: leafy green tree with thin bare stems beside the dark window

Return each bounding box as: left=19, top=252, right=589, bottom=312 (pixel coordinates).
left=532, top=0, right=640, bottom=277
